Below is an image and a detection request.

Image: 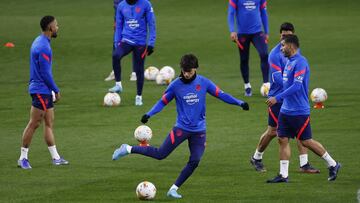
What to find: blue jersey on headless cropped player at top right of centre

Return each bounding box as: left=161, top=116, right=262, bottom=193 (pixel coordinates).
left=228, top=0, right=269, bottom=34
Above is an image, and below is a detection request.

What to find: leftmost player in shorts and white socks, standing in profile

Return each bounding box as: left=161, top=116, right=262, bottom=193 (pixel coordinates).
left=18, top=16, right=69, bottom=169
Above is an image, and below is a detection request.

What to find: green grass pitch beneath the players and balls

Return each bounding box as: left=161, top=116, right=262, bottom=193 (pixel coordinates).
left=0, top=0, right=360, bottom=202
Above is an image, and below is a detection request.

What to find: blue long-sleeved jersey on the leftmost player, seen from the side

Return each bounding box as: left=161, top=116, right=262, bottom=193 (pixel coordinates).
left=29, top=34, right=60, bottom=95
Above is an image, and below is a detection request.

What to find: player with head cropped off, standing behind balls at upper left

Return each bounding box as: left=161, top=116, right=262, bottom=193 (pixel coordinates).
left=109, top=0, right=156, bottom=106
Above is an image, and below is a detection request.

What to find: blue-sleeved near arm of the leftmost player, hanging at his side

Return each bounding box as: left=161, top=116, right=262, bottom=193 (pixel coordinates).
left=38, top=47, right=60, bottom=94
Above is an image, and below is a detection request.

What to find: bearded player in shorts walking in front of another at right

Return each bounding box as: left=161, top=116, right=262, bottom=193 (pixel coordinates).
left=266, top=35, right=341, bottom=183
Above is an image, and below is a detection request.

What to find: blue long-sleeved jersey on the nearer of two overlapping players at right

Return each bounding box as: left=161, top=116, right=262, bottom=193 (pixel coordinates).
left=275, top=51, right=310, bottom=115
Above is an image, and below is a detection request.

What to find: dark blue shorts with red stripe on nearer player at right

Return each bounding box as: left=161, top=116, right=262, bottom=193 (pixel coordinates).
left=277, top=112, right=312, bottom=140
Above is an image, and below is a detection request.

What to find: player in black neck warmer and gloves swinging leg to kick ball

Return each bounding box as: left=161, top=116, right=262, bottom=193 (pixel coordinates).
left=113, top=54, right=249, bottom=199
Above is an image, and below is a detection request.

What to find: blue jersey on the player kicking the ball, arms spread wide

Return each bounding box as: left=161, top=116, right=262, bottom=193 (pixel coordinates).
left=147, top=75, right=244, bottom=132
